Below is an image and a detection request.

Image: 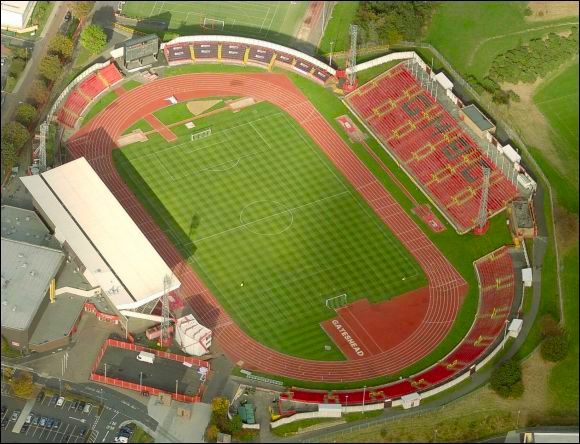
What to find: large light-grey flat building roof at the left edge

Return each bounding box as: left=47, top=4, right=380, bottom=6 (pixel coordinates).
left=1, top=238, right=64, bottom=330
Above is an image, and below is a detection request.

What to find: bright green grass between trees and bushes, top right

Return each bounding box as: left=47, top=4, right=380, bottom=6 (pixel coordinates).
left=426, top=2, right=578, bottom=78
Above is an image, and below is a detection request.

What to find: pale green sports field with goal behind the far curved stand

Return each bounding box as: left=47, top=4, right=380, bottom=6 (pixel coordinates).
left=123, top=1, right=308, bottom=43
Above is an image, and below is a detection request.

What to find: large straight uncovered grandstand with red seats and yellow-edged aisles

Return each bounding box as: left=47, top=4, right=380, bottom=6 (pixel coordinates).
left=346, top=63, right=517, bottom=233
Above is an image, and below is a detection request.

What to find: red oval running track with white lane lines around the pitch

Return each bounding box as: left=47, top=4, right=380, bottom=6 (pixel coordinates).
left=69, top=73, right=467, bottom=382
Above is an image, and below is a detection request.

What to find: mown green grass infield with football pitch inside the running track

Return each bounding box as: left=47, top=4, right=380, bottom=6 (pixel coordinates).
left=113, top=102, right=426, bottom=360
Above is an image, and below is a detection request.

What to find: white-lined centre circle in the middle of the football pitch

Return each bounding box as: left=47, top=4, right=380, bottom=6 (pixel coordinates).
left=240, top=200, right=294, bottom=236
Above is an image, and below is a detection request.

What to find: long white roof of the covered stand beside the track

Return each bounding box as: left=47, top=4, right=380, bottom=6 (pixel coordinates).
left=22, top=157, right=181, bottom=309
